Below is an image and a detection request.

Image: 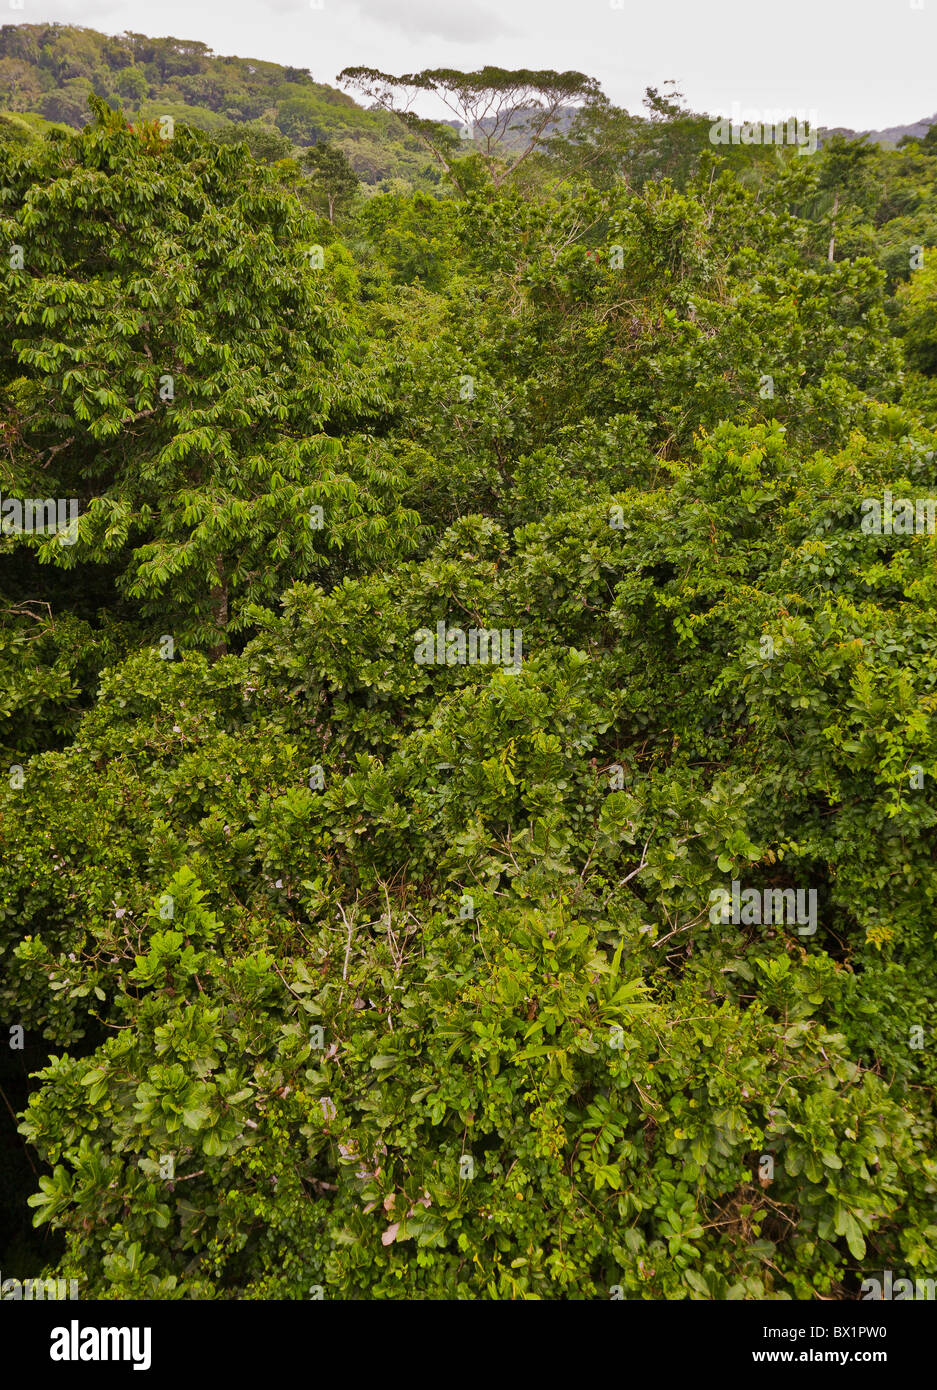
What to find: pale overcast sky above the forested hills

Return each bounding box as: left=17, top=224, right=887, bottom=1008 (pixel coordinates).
left=9, top=0, right=937, bottom=129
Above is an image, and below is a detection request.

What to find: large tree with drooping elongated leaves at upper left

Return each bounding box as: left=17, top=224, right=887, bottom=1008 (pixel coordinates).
left=0, top=108, right=413, bottom=656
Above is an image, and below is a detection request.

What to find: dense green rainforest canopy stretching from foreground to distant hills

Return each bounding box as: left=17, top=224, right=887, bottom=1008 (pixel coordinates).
left=0, top=46, right=937, bottom=1300
